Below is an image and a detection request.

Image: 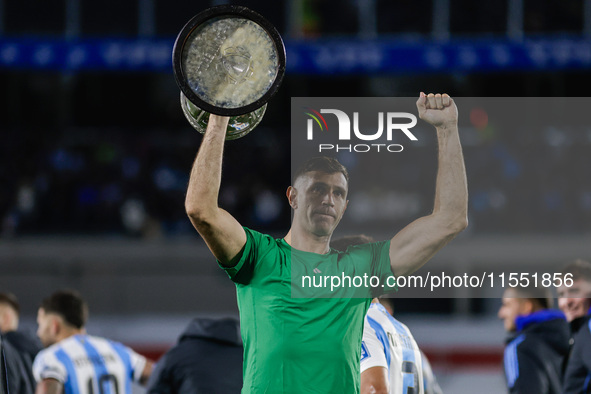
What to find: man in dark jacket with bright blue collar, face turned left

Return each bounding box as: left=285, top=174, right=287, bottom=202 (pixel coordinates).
left=498, top=286, right=569, bottom=394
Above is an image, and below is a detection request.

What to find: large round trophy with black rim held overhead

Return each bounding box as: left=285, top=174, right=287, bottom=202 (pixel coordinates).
left=172, top=5, right=285, bottom=140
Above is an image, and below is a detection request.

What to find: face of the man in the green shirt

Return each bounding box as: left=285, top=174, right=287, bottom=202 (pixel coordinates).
left=292, top=171, right=348, bottom=237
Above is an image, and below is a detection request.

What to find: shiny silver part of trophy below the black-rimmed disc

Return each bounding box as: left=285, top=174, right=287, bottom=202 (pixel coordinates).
left=181, top=92, right=267, bottom=140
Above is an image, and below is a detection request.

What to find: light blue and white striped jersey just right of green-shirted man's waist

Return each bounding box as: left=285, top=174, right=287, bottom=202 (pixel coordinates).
left=361, top=303, right=425, bottom=394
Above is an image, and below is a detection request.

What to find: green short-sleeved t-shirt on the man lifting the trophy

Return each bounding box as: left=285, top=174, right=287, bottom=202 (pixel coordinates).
left=222, top=228, right=392, bottom=394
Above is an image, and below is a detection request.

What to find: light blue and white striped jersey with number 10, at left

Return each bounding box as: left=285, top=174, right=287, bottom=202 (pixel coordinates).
left=33, top=335, right=146, bottom=394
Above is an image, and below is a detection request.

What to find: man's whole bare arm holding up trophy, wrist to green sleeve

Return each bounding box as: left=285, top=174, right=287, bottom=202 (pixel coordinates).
left=185, top=114, right=246, bottom=267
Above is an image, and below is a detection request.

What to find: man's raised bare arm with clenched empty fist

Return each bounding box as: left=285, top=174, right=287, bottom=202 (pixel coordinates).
left=390, top=92, right=468, bottom=275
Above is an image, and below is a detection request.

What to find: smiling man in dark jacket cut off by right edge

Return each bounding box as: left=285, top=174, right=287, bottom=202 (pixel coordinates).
left=558, top=260, right=591, bottom=393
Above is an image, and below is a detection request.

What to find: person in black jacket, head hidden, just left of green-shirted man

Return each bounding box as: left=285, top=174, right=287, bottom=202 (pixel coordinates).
left=147, top=318, right=242, bottom=394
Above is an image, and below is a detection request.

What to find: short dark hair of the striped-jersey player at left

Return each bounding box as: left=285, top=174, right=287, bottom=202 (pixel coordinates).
left=40, top=290, right=88, bottom=329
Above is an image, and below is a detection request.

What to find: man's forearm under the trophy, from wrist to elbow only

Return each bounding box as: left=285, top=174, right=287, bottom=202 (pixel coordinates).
left=185, top=114, right=228, bottom=221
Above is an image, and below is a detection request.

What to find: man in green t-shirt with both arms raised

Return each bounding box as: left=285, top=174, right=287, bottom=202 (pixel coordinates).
left=185, top=93, right=468, bottom=394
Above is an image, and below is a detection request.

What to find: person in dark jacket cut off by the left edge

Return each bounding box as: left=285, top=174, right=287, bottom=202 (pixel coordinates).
left=0, top=293, right=41, bottom=394
